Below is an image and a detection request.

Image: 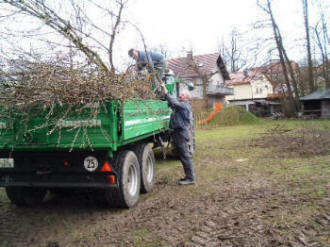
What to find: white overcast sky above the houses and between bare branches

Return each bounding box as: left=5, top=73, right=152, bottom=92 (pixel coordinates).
left=0, top=0, right=330, bottom=67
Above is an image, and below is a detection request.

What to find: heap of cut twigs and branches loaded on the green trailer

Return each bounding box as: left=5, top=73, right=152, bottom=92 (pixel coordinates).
left=0, top=60, right=155, bottom=106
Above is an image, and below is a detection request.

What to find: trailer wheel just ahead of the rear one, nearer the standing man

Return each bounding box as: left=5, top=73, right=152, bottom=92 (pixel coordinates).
left=132, top=143, right=155, bottom=193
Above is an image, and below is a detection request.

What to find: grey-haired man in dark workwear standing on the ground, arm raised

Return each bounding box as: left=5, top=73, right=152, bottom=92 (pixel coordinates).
left=161, top=83, right=195, bottom=185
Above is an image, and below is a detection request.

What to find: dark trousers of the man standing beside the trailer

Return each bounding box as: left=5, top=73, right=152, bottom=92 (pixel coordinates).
left=172, top=130, right=195, bottom=180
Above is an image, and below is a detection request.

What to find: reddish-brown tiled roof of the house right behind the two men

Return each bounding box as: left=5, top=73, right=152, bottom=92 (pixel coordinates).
left=167, top=53, right=219, bottom=78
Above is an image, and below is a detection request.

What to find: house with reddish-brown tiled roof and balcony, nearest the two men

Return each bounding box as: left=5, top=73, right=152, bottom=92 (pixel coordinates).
left=167, top=51, right=233, bottom=107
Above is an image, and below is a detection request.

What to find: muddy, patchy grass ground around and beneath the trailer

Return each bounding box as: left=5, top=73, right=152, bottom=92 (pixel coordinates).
left=0, top=122, right=330, bottom=247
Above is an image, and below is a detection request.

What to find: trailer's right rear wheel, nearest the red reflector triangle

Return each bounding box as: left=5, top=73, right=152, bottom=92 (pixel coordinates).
left=105, top=150, right=141, bottom=208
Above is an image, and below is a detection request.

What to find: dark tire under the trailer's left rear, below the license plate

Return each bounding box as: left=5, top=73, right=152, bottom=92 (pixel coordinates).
left=6, top=187, right=47, bottom=206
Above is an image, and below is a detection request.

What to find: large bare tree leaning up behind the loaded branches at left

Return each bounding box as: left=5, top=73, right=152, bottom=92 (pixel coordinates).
left=0, top=0, right=128, bottom=73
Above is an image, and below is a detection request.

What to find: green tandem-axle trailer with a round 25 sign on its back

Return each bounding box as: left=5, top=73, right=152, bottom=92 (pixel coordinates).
left=0, top=78, right=178, bottom=208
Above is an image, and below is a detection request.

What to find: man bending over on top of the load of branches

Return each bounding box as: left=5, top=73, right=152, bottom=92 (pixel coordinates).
left=128, top=49, right=166, bottom=80
